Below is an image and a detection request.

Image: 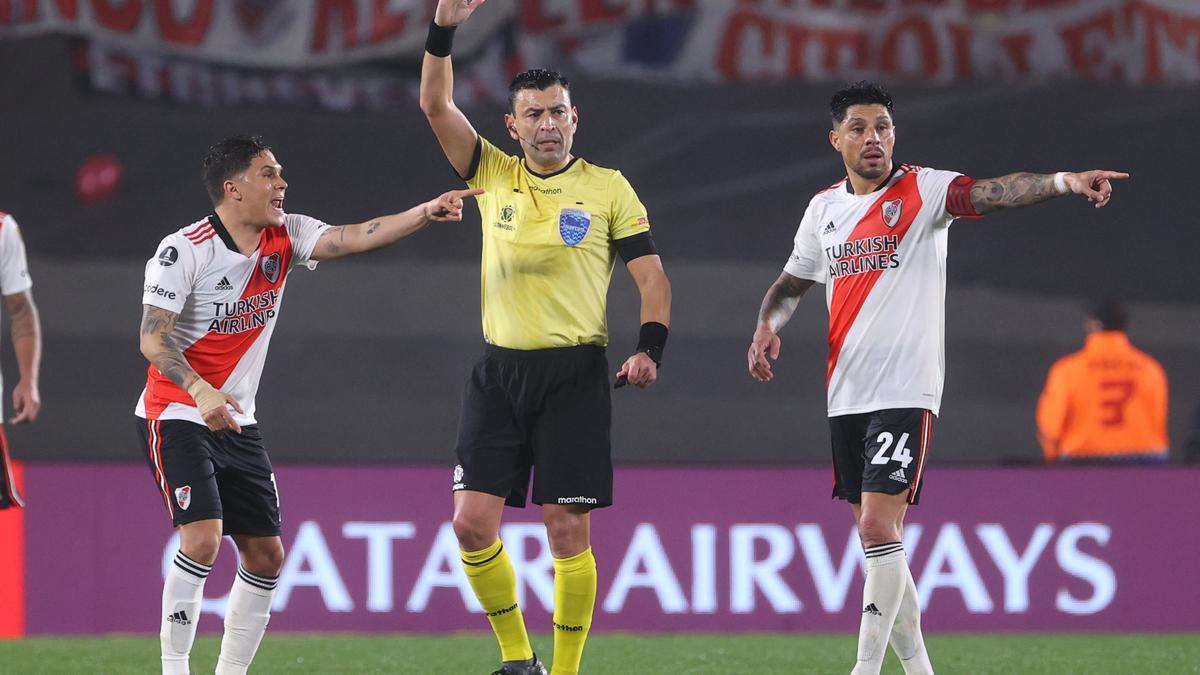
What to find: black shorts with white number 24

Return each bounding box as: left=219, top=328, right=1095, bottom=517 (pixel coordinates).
left=829, top=408, right=934, bottom=504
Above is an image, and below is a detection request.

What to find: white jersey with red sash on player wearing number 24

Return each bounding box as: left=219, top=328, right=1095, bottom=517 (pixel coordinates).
left=784, top=165, right=972, bottom=417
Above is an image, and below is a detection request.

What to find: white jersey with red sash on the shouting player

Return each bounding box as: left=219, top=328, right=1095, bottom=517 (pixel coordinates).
left=134, top=214, right=329, bottom=426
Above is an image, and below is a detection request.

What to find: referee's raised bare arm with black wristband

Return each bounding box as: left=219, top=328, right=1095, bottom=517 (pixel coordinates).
left=421, top=0, right=486, bottom=178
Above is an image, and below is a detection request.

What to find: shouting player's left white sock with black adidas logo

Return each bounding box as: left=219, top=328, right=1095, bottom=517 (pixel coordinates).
left=158, top=551, right=212, bottom=675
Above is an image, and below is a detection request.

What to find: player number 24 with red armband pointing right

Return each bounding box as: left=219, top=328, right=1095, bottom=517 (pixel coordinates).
left=746, top=82, right=1128, bottom=675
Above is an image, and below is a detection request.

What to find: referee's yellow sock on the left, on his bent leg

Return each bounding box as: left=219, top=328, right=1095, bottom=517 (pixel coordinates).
left=462, top=539, right=533, bottom=661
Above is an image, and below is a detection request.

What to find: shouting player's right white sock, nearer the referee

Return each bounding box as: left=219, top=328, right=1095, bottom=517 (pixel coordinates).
left=216, top=565, right=280, bottom=675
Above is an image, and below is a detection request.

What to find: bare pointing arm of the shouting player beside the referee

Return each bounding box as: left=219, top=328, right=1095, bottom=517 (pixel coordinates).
left=311, top=190, right=484, bottom=261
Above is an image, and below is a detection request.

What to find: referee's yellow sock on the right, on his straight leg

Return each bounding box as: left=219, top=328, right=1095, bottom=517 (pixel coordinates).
left=550, top=548, right=596, bottom=675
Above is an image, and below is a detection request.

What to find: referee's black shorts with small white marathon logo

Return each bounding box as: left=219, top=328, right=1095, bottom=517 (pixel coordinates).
left=452, top=345, right=612, bottom=508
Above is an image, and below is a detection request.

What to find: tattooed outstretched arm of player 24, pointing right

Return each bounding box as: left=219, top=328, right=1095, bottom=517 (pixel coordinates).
left=971, top=169, right=1129, bottom=214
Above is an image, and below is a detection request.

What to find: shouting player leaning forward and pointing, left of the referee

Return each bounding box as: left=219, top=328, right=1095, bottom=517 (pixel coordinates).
left=136, top=136, right=480, bottom=674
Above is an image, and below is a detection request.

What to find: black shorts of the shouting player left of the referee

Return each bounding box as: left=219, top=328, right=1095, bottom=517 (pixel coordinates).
left=138, top=417, right=280, bottom=537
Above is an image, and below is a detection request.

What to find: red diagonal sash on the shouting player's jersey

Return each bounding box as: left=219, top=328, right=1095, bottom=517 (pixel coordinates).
left=145, top=226, right=292, bottom=419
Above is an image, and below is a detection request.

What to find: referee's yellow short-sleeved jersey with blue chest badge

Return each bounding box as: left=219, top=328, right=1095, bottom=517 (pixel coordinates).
left=467, top=137, right=650, bottom=350
